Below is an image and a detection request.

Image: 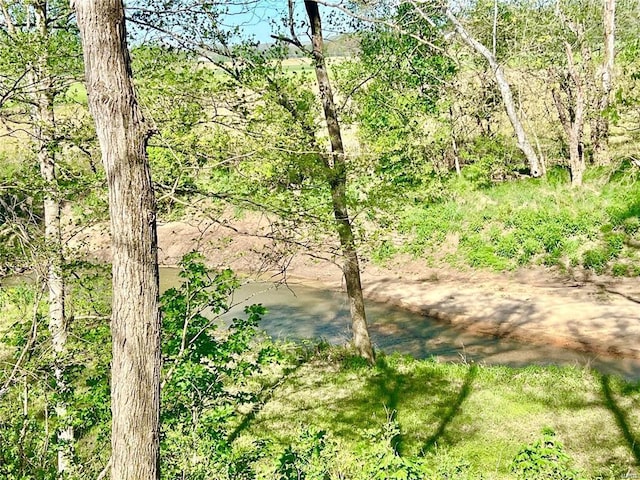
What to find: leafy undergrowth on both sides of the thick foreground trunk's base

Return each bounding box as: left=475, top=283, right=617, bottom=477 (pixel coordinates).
left=0, top=253, right=278, bottom=480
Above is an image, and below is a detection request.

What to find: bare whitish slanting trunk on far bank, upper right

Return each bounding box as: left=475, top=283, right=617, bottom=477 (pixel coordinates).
left=445, top=8, right=544, bottom=177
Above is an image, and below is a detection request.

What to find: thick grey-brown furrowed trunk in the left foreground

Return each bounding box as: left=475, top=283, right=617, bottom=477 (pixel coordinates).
left=75, top=0, right=160, bottom=480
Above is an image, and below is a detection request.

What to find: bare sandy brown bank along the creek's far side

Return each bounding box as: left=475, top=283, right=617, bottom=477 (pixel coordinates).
left=74, top=215, right=640, bottom=358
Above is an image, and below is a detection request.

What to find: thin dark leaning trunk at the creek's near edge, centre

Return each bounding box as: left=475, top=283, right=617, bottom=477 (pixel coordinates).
left=304, top=0, right=375, bottom=363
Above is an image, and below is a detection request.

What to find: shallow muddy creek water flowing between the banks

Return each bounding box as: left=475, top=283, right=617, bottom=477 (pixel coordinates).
left=161, top=269, right=640, bottom=380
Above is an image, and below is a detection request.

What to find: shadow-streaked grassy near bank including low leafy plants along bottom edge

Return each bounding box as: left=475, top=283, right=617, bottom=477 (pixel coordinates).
left=232, top=347, right=640, bottom=480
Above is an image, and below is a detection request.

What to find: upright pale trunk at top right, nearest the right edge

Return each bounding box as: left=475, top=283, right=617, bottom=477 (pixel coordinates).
left=591, top=0, right=616, bottom=165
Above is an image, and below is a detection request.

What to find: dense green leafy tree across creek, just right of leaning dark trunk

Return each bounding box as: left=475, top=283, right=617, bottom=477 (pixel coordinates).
left=333, top=3, right=457, bottom=184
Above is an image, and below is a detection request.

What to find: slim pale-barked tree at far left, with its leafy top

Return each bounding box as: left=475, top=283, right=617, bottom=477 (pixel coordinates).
left=0, top=0, right=78, bottom=474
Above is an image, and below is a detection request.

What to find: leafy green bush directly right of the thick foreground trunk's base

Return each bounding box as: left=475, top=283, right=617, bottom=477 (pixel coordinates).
left=161, top=253, right=276, bottom=479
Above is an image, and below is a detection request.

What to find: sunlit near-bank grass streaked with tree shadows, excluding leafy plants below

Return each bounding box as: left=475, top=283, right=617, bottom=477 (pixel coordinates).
left=238, top=349, right=640, bottom=479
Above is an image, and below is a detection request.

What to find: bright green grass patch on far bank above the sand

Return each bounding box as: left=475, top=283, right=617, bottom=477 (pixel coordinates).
left=392, top=168, right=640, bottom=276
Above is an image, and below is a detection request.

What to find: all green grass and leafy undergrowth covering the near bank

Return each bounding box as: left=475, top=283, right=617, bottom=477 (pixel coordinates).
left=5, top=254, right=640, bottom=480
